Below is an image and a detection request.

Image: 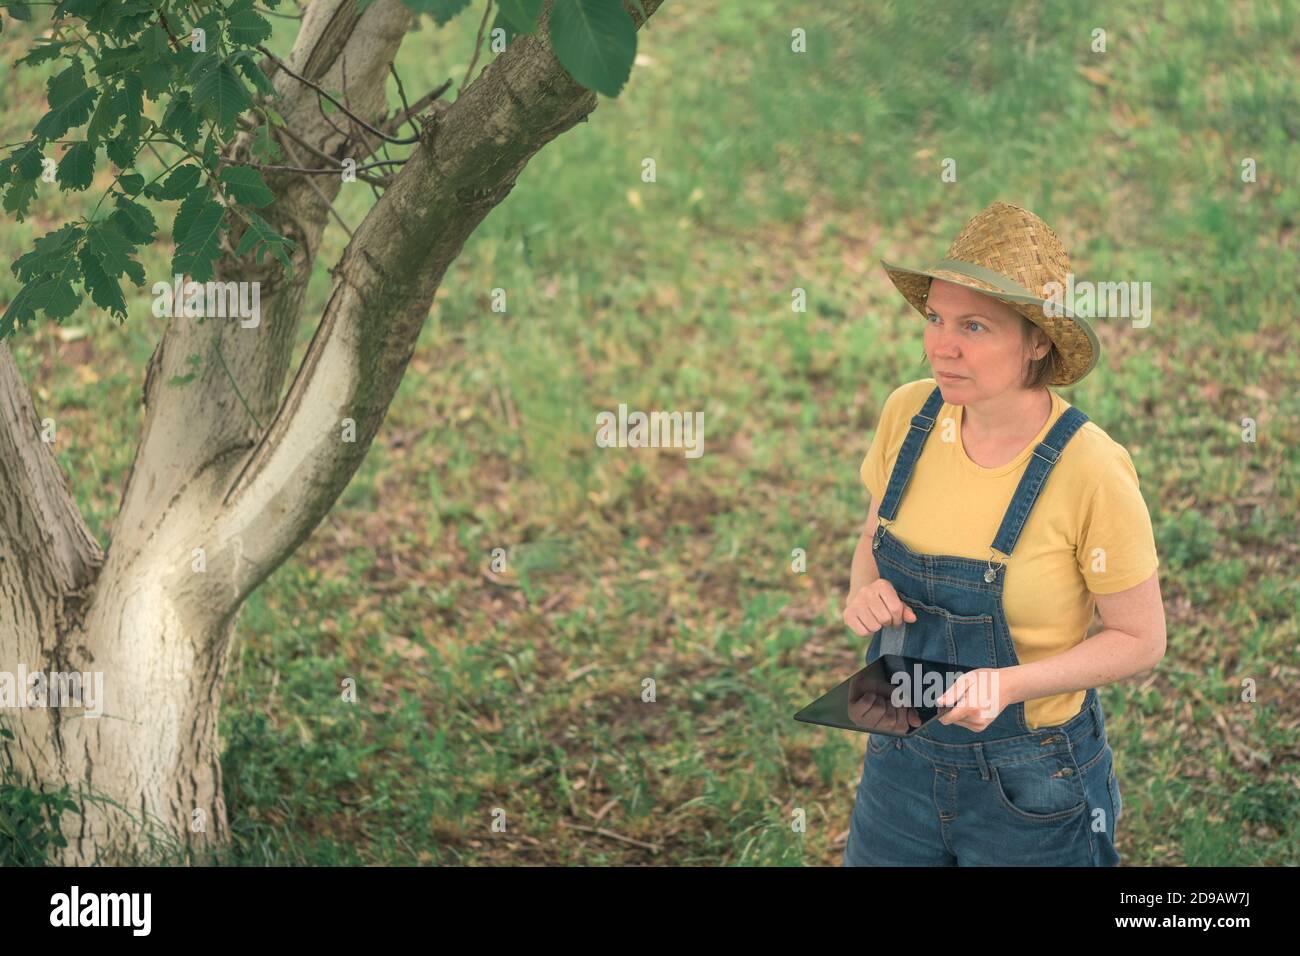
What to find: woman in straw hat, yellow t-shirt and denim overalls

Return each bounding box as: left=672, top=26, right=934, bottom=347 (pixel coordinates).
left=844, top=203, right=1165, bottom=866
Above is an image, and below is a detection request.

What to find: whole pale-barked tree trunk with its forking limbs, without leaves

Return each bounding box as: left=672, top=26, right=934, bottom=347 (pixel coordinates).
left=0, top=0, right=662, bottom=862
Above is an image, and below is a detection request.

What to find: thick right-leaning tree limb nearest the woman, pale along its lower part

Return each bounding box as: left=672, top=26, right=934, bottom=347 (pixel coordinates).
left=215, top=0, right=662, bottom=601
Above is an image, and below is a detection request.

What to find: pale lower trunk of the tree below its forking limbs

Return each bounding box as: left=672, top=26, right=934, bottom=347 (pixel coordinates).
left=0, top=538, right=233, bottom=864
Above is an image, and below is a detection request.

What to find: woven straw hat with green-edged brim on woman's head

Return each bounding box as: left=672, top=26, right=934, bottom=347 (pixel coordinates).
left=880, top=202, right=1101, bottom=385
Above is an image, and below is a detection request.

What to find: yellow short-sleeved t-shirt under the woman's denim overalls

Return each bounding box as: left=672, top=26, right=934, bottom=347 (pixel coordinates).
left=861, top=378, right=1160, bottom=727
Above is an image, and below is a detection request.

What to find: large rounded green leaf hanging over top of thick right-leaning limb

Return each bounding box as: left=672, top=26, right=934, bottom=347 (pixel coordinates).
left=550, top=0, right=637, bottom=96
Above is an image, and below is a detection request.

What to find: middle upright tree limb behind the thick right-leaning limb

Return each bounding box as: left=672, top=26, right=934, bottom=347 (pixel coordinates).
left=113, top=0, right=412, bottom=567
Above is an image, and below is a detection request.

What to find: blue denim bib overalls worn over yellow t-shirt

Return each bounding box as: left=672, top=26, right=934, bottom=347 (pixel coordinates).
left=844, top=388, right=1121, bottom=866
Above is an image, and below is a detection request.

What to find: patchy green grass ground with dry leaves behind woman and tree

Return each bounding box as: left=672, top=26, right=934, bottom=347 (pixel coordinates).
left=0, top=0, right=1300, bottom=865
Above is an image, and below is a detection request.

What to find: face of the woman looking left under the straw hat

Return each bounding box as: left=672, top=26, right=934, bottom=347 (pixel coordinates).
left=926, top=278, right=1050, bottom=405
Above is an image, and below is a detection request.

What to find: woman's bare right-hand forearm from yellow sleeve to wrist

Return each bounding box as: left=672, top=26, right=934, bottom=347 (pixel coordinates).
left=998, top=571, right=1165, bottom=706
